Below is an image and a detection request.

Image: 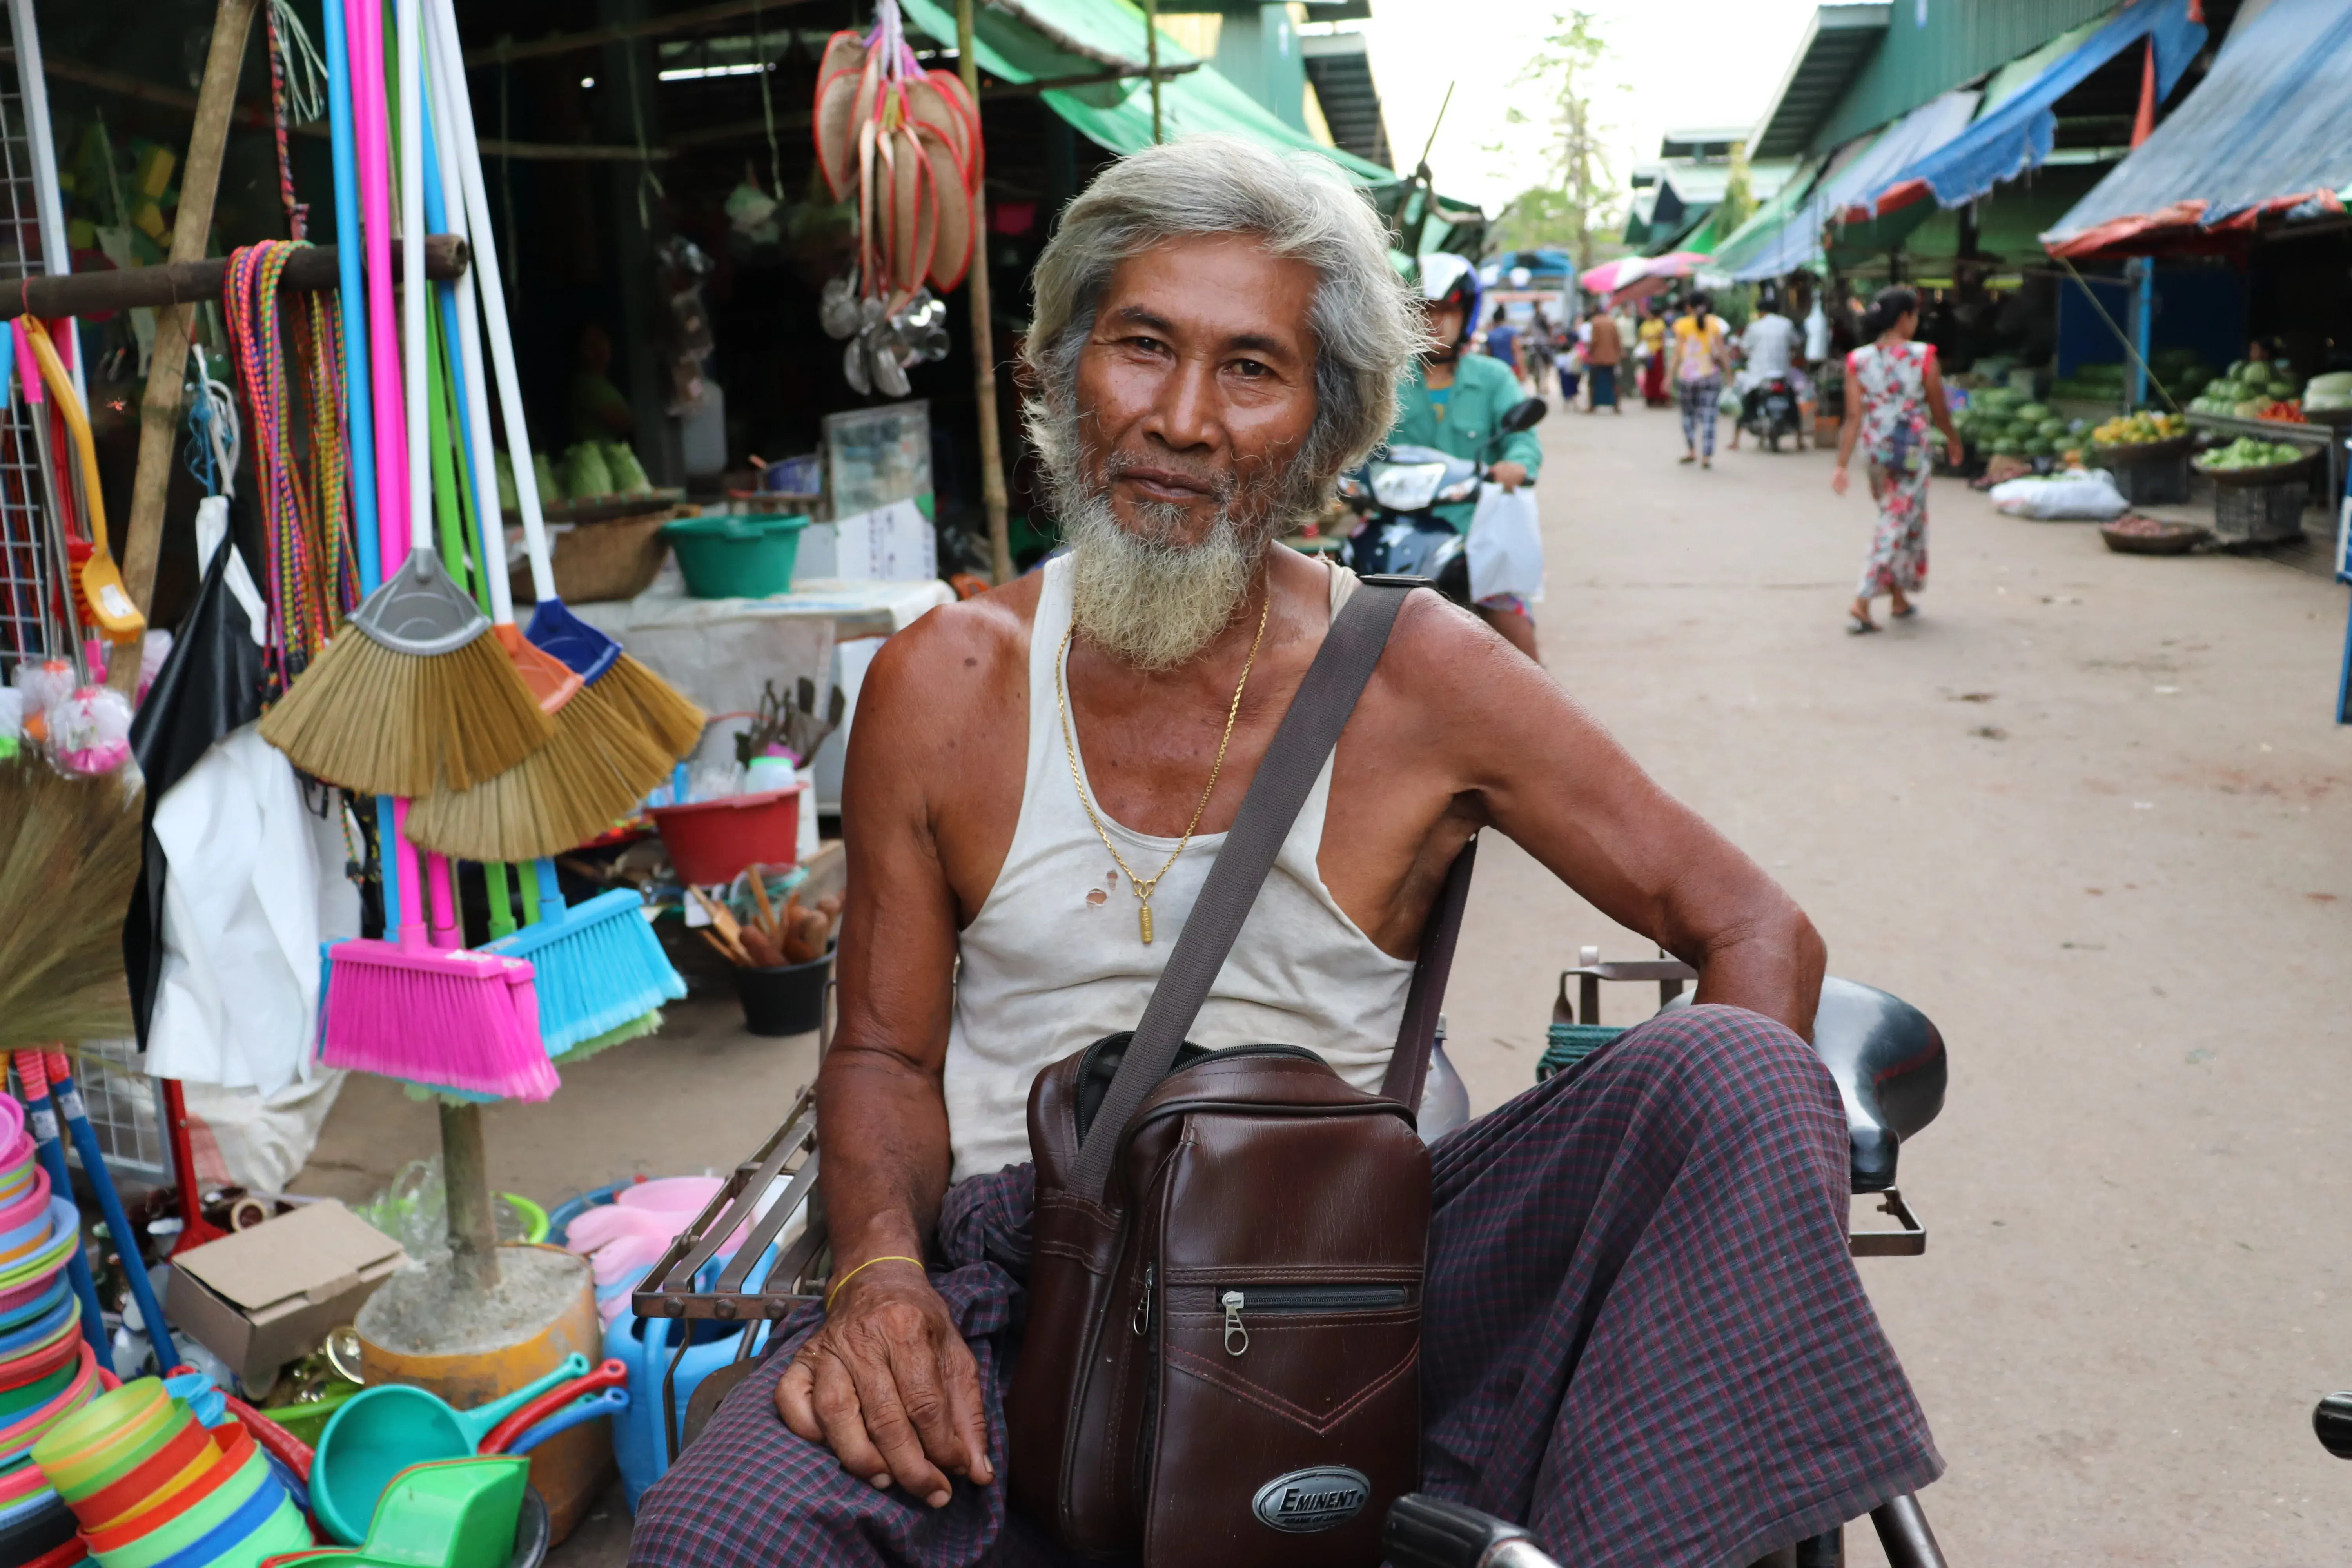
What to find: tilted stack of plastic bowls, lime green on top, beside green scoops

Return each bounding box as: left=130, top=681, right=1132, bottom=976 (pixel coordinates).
left=33, top=1377, right=313, bottom=1568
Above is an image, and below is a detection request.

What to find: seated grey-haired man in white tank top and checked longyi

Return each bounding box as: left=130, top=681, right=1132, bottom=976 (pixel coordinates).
left=633, top=139, right=1940, bottom=1568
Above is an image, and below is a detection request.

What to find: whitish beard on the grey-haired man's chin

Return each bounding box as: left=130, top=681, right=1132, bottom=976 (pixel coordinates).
left=1056, top=484, right=1272, bottom=670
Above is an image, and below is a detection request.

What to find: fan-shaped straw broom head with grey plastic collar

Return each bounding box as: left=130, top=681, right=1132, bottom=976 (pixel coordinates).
left=261, top=550, right=555, bottom=799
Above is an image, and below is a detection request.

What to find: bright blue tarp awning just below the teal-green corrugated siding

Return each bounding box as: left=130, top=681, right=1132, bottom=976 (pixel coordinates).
left=1863, top=0, right=2206, bottom=214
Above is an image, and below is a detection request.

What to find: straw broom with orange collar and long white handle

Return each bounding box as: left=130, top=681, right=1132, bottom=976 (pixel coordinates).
left=409, top=58, right=673, bottom=860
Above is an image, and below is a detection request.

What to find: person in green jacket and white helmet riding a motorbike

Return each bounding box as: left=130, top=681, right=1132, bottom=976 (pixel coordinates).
left=1388, top=254, right=1543, bottom=658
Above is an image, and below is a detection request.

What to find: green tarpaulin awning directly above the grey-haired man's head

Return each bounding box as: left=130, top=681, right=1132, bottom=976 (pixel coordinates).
left=901, top=0, right=1397, bottom=188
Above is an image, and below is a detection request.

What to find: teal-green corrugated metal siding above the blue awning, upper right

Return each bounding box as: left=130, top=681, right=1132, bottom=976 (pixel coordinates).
left=1811, top=0, right=2145, bottom=153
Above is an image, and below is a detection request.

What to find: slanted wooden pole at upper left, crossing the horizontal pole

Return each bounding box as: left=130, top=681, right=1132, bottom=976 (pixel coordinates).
left=106, top=0, right=261, bottom=696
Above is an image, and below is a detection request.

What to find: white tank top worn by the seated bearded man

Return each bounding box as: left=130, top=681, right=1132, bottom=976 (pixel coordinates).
left=946, top=557, right=1414, bottom=1180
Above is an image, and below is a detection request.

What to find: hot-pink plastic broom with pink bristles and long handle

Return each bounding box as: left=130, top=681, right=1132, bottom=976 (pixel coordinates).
left=320, top=0, right=560, bottom=1100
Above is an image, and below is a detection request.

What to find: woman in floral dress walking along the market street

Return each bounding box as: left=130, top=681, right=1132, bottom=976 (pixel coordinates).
left=1830, top=289, right=1962, bottom=635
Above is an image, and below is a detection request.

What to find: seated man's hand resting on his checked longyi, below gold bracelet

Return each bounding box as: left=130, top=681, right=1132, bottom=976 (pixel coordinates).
left=776, top=1260, right=995, bottom=1507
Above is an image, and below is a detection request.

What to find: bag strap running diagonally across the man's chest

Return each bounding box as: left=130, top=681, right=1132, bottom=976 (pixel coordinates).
left=1070, top=578, right=1411, bottom=1201
